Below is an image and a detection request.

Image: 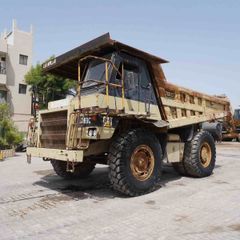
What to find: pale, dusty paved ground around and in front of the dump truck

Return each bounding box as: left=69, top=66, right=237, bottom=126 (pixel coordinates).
left=0, top=142, right=240, bottom=240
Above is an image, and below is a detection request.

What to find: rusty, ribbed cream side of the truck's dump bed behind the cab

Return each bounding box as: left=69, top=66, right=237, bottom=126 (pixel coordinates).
left=158, top=82, right=230, bottom=128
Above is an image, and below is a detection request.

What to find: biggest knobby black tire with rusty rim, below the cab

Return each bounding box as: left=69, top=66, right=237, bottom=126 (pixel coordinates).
left=108, top=129, right=162, bottom=196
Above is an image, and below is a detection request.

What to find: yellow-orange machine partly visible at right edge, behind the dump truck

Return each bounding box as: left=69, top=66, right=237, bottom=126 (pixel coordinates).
left=222, top=109, right=240, bottom=142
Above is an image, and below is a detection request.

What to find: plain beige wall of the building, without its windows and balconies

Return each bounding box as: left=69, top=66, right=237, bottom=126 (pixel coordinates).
left=0, top=21, right=33, bottom=132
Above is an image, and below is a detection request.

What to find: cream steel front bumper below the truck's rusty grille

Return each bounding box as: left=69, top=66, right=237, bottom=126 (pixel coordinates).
left=27, top=147, right=83, bottom=162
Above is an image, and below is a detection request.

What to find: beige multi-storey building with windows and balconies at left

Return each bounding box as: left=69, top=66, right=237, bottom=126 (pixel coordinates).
left=0, top=20, right=33, bottom=132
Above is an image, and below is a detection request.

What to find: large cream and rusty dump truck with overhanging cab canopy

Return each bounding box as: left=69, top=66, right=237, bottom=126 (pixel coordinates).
left=27, top=34, right=232, bottom=196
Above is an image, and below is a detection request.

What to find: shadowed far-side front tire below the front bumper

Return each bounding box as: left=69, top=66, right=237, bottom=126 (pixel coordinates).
left=51, top=159, right=96, bottom=179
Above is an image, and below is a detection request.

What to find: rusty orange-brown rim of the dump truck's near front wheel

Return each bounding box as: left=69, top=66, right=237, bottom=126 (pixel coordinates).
left=130, top=145, right=155, bottom=181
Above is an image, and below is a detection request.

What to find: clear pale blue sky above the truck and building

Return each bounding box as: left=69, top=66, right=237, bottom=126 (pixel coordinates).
left=0, top=0, right=240, bottom=108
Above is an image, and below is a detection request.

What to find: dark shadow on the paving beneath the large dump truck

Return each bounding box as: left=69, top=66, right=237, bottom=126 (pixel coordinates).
left=34, top=166, right=181, bottom=201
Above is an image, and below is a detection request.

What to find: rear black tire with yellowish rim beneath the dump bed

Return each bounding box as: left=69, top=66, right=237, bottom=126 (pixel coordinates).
left=173, top=131, right=216, bottom=177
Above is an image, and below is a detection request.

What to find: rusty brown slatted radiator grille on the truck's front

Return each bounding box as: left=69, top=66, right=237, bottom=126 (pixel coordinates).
left=40, top=110, right=67, bottom=149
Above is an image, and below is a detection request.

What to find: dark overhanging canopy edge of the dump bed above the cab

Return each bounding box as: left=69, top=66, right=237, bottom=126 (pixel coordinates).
left=42, top=33, right=168, bottom=78
